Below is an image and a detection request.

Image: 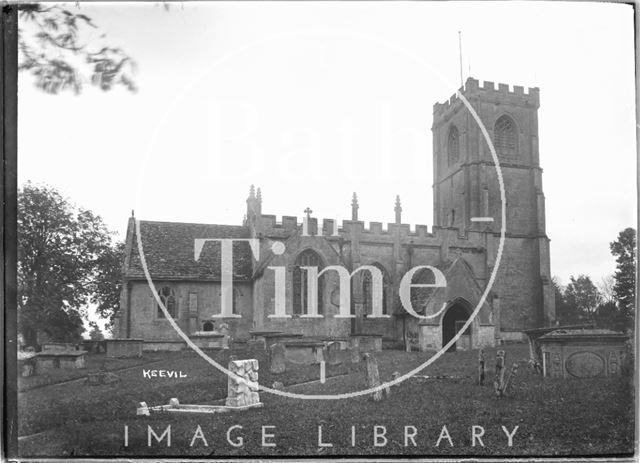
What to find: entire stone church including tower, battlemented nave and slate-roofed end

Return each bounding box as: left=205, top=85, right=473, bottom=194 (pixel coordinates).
left=114, top=78, right=555, bottom=350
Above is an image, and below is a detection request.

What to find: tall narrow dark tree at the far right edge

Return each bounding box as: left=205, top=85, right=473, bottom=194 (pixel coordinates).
left=609, top=227, right=636, bottom=316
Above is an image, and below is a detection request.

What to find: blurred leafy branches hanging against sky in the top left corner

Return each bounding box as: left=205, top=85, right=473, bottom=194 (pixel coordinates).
left=18, top=3, right=136, bottom=94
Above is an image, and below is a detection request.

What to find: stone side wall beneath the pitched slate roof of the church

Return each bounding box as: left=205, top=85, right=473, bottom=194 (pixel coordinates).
left=124, top=281, right=253, bottom=341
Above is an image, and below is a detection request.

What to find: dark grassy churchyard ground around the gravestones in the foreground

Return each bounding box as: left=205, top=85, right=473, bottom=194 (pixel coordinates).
left=19, top=344, right=634, bottom=456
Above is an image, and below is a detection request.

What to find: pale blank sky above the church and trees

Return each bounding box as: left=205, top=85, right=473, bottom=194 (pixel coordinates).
left=18, top=2, right=637, bottom=330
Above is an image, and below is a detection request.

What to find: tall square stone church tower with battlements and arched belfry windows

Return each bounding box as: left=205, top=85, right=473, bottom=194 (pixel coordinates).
left=432, top=78, right=555, bottom=339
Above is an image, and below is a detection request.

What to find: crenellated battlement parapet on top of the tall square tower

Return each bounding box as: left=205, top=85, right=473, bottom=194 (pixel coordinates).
left=433, top=77, right=540, bottom=115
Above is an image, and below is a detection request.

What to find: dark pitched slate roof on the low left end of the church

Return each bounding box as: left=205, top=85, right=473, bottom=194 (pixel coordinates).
left=125, top=221, right=253, bottom=281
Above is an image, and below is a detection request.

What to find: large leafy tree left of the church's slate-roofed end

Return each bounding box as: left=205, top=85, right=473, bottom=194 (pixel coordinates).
left=18, top=183, right=119, bottom=345
